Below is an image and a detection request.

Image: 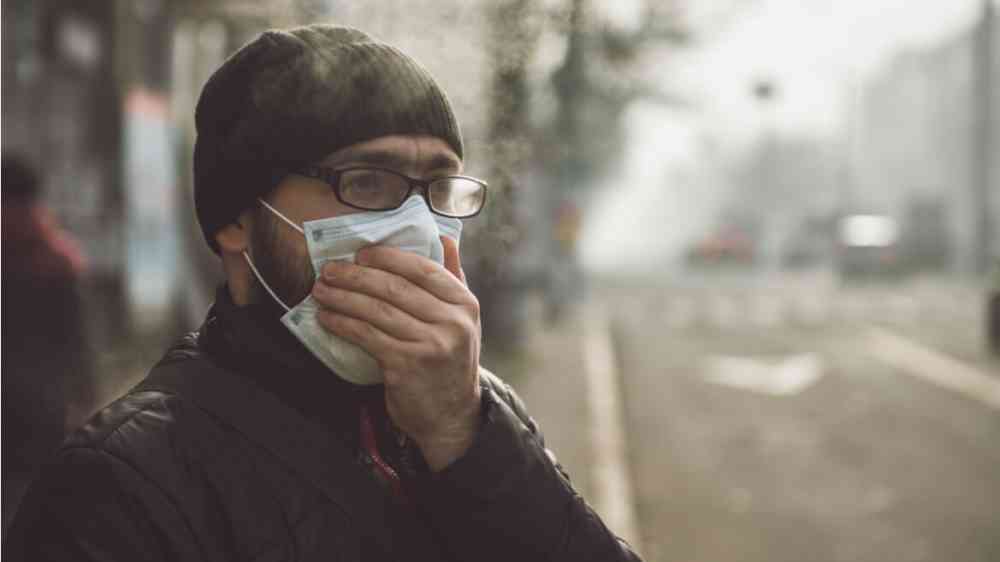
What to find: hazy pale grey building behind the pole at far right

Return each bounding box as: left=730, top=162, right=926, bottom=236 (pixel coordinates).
left=851, top=2, right=1000, bottom=272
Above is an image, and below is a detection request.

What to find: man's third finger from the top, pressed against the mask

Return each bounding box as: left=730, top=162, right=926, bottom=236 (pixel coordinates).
left=312, top=283, right=427, bottom=341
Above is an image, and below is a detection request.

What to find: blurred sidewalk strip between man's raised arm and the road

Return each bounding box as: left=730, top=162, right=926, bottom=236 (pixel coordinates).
left=483, top=297, right=643, bottom=552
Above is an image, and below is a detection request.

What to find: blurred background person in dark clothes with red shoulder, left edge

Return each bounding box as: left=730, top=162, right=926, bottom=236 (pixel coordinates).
left=2, top=152, right=93, bottom=531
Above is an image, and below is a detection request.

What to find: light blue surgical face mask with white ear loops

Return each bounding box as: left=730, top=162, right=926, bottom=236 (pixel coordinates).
left=243, top=195, right=462, bottom=385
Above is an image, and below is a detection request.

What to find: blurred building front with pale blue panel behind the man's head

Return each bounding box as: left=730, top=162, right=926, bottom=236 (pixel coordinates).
left=3, top=0, right=304, bottom=402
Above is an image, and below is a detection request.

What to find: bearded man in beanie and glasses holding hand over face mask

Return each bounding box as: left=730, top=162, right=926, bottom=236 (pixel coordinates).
left=4, top=25, right=636, bottom=560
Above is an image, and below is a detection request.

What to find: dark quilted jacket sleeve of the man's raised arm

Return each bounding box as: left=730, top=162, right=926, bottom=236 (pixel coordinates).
left=417, top=372, right=639, bottom=561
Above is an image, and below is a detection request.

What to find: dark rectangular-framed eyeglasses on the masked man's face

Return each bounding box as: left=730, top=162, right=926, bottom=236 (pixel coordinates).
left=295, top=166, right=486, bottom=219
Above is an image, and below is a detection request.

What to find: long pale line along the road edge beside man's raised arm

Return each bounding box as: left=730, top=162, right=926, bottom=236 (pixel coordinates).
left=584, top=306, right=642, bottom=553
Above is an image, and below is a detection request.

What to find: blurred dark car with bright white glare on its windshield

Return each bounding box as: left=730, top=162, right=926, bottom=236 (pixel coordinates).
left=837, top=214, right=903, bottom=280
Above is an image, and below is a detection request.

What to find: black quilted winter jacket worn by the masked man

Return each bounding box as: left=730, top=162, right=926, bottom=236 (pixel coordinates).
left=3, top=288, right=637, bottom=562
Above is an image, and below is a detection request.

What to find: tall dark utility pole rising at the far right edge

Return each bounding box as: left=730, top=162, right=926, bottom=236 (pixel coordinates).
left=970, top=0, right=997, bottom=274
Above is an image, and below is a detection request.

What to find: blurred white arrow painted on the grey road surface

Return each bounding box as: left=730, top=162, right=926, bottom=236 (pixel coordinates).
left=705, top=353, right=823, bottom=396
